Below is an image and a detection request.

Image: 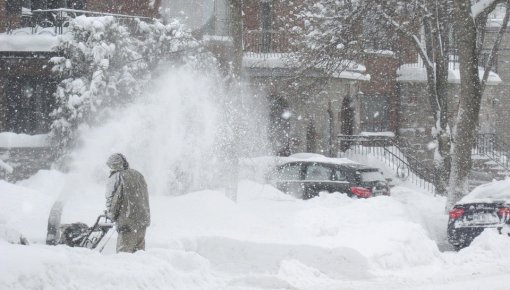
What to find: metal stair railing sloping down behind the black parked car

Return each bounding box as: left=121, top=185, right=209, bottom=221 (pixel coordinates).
left=338, top=135, right=435, bottom=193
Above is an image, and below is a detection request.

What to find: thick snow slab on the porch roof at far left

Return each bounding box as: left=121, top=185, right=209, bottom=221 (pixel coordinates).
left=0, top=33, right=58, bottom=51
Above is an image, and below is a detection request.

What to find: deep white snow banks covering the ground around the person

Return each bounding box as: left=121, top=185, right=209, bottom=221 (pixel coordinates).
left=0, top=178, right=510, bottom=289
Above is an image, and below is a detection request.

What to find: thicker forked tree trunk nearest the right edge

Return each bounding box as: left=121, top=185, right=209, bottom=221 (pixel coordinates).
left=446, top=0, right=510, bottom=210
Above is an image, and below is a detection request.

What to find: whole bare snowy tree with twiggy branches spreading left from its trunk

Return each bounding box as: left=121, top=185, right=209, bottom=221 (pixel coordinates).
left=299, top=0, right=452, bottom=195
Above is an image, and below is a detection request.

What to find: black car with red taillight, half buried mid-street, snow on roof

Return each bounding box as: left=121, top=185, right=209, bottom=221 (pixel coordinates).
left=268, top=157, right=390, bottom=199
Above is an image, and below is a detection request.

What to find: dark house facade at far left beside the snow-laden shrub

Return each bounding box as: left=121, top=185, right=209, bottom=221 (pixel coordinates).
left=0, top=0, right=160, bottom=180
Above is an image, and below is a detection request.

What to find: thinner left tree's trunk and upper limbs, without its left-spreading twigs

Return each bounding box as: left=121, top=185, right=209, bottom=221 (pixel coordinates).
left=377, top=0, right=452, bottom=195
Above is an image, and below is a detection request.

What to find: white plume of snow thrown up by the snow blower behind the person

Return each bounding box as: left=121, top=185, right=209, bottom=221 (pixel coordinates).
left=58, top=66, right=264, bottom=195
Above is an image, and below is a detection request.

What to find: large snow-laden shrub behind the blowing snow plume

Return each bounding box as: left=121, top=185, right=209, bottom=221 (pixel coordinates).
left=51, top=16, right=198, bottom=154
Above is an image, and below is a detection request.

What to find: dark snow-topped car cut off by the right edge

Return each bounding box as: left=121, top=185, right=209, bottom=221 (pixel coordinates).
left=447, top=180, right=510, bottom=250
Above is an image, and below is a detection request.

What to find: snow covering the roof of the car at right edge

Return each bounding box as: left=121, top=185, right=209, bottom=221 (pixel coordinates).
left=457, top=178, right=510, bottom=204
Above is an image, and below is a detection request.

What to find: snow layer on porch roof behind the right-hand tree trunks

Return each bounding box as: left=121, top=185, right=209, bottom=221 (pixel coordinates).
left=397, top=63, right=502, bottom=85
